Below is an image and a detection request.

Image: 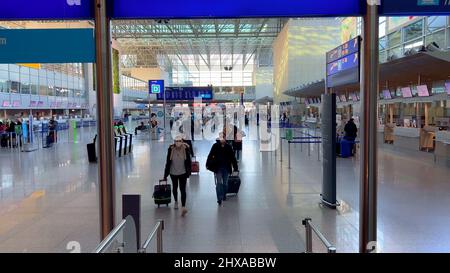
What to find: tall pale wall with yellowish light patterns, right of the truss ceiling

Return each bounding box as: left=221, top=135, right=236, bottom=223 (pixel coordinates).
left=273, top=18, right=341, bottom=103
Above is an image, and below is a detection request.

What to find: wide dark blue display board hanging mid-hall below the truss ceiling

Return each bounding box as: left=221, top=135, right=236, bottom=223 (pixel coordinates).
left=156, top=87, right=213, bottom=101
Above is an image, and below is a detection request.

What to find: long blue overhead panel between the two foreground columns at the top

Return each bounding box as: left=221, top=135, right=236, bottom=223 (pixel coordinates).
left=112, top=0, right=365, bottom=19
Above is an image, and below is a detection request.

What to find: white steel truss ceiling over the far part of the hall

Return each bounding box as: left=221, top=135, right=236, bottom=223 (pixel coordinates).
left=111, top=18, right=287, bottom=70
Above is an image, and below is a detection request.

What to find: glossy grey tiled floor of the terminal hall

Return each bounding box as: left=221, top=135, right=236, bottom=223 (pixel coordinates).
left=0, top=126, right=450, bottom=252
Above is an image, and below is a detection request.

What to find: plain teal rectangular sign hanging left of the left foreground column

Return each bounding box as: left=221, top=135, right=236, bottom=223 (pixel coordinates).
left=0, top=29, right=95, bottom=63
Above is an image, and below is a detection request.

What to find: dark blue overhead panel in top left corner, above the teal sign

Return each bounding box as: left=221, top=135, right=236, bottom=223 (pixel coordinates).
left=0, top=0, right=94, bottom=20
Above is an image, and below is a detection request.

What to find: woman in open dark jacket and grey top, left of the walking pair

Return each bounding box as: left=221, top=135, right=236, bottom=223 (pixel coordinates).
left=164, top=137, right=191, bottom=216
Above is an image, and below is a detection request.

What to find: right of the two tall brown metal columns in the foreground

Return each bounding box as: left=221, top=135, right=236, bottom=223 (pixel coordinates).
left=359, top=1, right=379, bottom=253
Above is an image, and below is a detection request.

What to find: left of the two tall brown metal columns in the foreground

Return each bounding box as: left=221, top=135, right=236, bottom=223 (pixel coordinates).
left=95, top=0, right=115, bottom=239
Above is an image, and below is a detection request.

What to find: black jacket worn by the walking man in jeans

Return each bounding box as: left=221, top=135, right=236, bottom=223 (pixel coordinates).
left=206, top=141, right=239, bottom=173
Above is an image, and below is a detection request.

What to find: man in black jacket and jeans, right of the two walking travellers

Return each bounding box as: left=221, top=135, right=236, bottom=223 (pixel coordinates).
left=206, top=132, right=239, bottom=206
